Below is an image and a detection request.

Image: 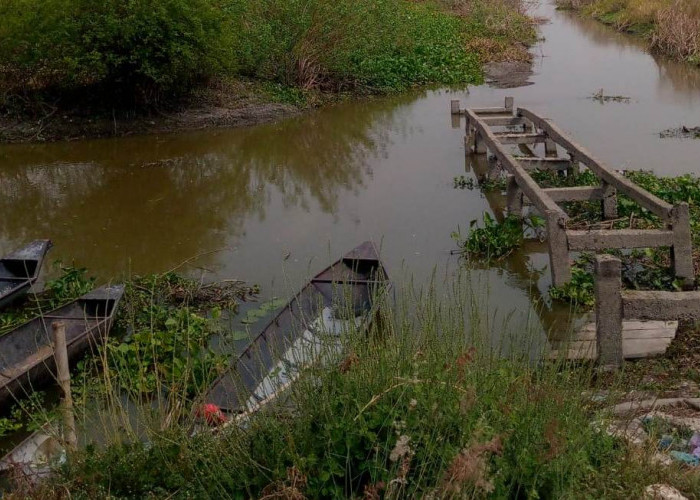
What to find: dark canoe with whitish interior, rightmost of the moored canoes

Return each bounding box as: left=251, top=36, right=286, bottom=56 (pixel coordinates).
left=204, top=242, right=390, bottom=416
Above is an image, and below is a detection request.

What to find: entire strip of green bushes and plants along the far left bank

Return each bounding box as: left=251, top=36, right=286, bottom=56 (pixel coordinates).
left=0, top=0, right=532, bottom=104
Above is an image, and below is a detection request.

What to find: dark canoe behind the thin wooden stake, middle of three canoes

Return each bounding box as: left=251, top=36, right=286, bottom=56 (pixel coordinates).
left=0, top=285, right=124, bottom=405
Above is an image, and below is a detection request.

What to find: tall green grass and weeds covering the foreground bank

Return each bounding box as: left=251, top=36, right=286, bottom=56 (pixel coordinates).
left=8, top=272, right=700, bottom=499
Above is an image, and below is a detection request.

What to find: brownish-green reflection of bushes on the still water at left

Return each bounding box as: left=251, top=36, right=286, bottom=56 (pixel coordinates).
left=0, top=96, right=413, bottom=276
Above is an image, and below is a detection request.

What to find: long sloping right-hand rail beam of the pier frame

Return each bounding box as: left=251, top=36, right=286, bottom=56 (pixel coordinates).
left=517, top=108, right=673, bottom=221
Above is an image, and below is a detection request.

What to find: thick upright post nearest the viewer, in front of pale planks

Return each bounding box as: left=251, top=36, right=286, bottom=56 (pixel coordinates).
left=595, top=255, right=624, bottom=370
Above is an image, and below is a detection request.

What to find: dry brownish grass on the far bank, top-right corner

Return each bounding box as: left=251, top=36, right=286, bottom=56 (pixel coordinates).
left=557, top=0, right=700, bottom=65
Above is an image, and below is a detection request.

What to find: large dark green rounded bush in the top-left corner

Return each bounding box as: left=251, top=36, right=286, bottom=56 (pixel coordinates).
left=0, top=0, right=233, bottom=99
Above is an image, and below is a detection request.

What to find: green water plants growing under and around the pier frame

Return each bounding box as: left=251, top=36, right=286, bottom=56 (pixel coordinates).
left=453, top=169, right=700, bottom=309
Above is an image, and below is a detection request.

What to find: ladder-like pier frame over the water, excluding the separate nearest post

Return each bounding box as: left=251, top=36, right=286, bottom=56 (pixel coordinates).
left=451, top=97, right=695, bottom=287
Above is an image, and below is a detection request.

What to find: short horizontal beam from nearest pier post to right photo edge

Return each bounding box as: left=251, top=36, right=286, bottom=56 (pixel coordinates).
left=622, top=290, right=700, bottom=321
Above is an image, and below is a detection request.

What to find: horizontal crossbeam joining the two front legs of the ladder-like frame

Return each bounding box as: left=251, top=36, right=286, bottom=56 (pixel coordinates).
left=566, top=229, right=673, bottom=251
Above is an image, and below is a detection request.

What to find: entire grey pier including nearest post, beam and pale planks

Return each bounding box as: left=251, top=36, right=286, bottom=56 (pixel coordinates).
left=451, top=97, right=700, bottom=368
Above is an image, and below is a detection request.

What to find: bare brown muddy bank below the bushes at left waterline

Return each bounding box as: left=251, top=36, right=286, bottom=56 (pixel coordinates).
left=0, top=82, right=302, bottom=143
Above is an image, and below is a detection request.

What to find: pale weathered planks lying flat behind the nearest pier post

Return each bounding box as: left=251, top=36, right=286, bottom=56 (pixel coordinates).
left=549, top=321, right=678, bottom=360
